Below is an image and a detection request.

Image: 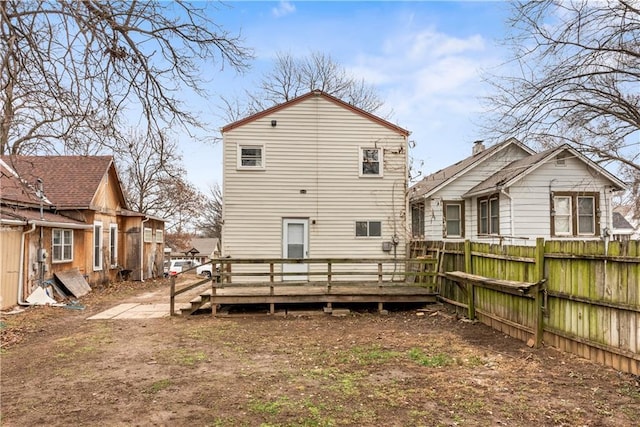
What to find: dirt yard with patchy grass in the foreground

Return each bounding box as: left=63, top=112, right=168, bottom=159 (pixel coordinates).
left=0, top=282, right=640, bottom=426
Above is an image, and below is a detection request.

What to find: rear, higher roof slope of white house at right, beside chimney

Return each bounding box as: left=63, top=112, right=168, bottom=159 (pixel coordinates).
left=409, top=138, right=534, bottom=199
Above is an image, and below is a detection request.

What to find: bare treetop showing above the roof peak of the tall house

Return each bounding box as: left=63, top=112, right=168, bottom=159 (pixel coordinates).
left=223, top=52, right=384, bottom=122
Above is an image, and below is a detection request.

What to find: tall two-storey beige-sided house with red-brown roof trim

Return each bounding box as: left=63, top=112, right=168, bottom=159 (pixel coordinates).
left=222, top=91, right=409, bottom=280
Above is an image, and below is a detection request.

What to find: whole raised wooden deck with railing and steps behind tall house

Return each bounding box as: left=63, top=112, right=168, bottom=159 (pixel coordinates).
left=171, top=257, right=438, bottom=316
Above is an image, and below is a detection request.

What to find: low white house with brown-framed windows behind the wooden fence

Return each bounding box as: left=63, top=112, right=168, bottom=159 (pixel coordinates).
left=409, top=139, right=625, bottom=244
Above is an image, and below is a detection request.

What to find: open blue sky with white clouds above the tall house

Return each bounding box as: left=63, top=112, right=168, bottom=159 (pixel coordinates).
left=180, top=1, right=508, bottom=189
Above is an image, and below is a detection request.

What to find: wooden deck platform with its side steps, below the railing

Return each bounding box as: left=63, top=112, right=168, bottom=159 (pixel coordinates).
left=181, top=283, right=437, bottom=316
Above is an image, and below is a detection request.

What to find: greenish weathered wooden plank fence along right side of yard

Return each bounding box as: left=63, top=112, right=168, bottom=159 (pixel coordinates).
left=410, top=239, right=640, bottom=375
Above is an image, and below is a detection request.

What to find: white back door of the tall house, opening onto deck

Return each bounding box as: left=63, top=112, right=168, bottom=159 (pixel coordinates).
left=282, top=218, right=309, bottom=281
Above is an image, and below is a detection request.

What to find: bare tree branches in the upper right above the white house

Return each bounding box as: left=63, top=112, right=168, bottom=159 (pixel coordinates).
left=488, top=0, right=640, bottom=208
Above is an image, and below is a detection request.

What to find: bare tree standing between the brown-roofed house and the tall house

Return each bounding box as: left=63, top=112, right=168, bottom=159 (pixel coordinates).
left=117, top=131, right=204, bottom=232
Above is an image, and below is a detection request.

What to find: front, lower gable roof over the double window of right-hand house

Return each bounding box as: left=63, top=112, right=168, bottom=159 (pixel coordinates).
left=463, top=144, right=626, bottom=197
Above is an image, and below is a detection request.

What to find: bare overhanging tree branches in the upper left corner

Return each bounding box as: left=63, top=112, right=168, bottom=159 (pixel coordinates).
left=0, top=0, right=251, bottom=154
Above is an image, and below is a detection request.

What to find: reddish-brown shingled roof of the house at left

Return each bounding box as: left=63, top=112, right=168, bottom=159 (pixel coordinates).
left=0, top=156, right=126, bottom=209
